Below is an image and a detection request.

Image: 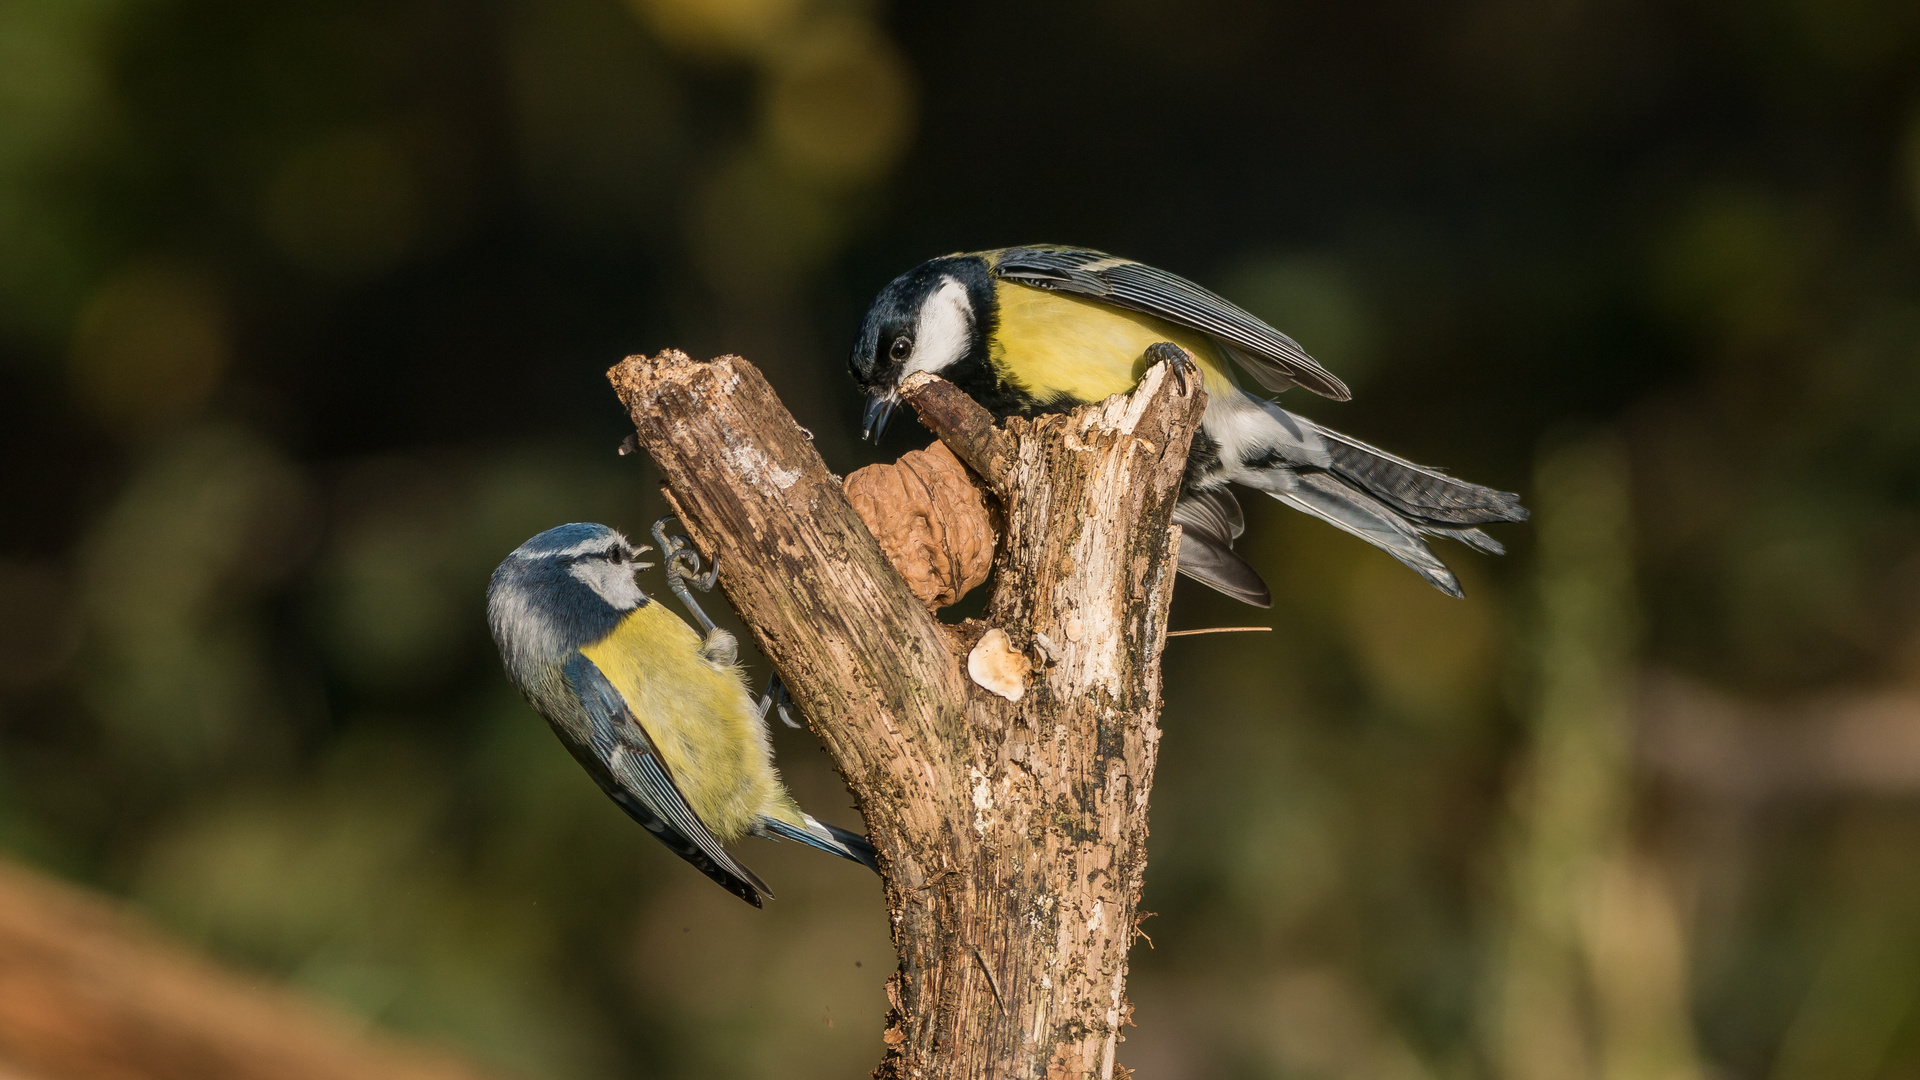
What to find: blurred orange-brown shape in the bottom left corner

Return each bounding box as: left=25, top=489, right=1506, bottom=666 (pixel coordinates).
left=0, top=861, right=503, bottom=1080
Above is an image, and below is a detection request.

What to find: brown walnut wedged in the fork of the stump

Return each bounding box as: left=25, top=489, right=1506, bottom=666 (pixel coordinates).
left=845, top=442, right=1000, bottom=607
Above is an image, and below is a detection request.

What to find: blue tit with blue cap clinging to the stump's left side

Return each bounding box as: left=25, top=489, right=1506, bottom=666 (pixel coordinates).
left=488, top=523, right=876, bottom=907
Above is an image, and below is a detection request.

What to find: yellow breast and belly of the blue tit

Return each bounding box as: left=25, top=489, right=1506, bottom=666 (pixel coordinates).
left=580, top=601, right=791, bottom=840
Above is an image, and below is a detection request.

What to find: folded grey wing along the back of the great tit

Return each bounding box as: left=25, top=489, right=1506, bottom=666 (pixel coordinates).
left=993, top=248, right=1352, bottom=402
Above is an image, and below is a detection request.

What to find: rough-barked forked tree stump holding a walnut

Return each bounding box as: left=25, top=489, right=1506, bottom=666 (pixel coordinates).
left=611, top=352, right=1206, bottom=1080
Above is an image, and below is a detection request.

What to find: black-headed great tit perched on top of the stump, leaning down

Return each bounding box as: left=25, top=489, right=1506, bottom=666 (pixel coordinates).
left=852, top=244, right=1526, bottom=607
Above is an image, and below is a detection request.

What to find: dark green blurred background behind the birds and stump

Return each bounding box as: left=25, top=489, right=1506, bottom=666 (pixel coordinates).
left=0, top=0, right=1920, bottom=1080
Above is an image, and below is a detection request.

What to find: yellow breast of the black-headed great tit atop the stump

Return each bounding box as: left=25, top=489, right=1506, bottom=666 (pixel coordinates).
left=987, top=281, right=1235, bottom=404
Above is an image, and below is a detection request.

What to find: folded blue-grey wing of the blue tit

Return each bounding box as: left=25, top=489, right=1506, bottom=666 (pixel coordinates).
left=566, top=657, right=774, bottom=907
